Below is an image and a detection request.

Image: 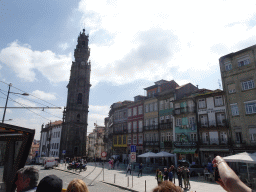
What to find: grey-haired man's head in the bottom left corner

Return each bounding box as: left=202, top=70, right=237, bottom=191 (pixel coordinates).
left=15, top=166, right=39, bottom=192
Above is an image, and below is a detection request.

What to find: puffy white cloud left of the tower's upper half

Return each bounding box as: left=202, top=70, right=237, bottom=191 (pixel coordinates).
left=0, top=41, right=72, bottom=83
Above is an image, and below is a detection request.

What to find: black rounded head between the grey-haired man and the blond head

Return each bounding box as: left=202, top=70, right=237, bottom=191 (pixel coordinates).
left=36, top=175, right=63, bottom=192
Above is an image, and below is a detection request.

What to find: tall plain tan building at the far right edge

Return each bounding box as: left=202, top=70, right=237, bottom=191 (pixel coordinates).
left=219, top=45, right=256, bottom=153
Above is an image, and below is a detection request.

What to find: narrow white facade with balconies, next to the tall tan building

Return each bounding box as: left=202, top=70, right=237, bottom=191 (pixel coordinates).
left=196, top=90, right=231, bottom=165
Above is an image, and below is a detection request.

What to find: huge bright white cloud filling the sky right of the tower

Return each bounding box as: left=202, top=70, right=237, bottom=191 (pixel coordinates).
left=76, top=0, right=256, bottom=86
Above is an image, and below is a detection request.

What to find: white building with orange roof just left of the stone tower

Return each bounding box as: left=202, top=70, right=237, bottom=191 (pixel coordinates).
left=39, top=121, right=62, bottom=157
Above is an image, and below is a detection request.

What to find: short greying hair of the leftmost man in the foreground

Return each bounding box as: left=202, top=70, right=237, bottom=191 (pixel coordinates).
left=17, top=166, right=39, bottom=189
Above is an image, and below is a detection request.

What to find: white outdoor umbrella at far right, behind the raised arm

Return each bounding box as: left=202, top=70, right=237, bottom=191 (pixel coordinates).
left=223, top=152, right=256, bottom=180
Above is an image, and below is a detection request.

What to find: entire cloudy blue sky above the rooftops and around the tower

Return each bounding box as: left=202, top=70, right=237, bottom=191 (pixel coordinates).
left=0, top=0, right=256, bottom=139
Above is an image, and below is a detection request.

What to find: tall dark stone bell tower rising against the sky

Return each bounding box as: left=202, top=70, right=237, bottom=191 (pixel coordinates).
left=60, top=29, right=91, bottom=158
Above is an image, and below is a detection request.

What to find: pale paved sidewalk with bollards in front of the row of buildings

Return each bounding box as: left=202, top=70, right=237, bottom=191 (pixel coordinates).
left=56, top=163, right=225, bottom=192
